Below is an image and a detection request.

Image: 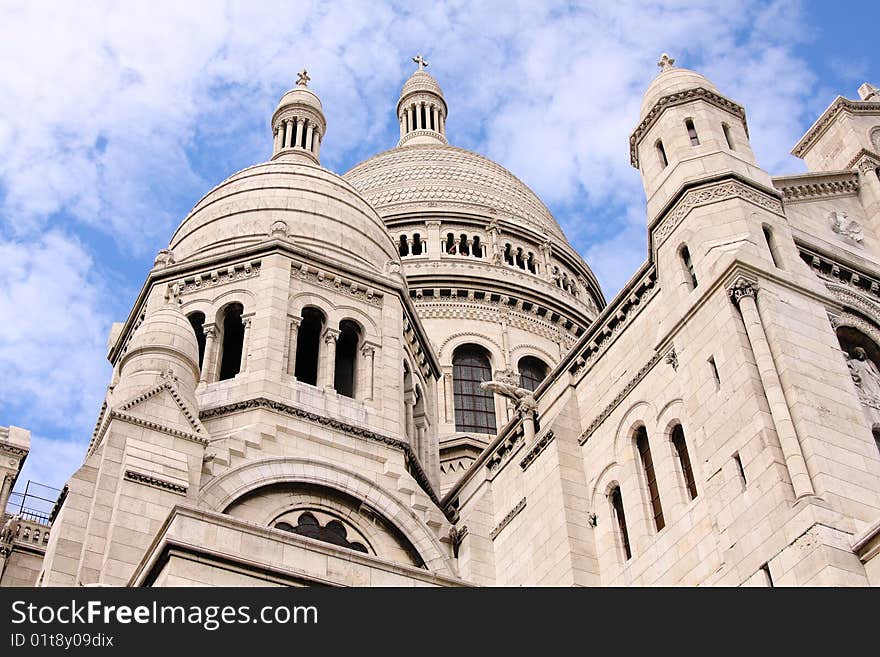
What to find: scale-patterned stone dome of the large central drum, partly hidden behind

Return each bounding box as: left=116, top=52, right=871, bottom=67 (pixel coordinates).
left=343, top=144, right=565, bottom=241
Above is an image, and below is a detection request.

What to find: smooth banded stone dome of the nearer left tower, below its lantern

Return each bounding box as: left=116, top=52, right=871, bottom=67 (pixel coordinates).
left=170, top=160, right=400, bottom=272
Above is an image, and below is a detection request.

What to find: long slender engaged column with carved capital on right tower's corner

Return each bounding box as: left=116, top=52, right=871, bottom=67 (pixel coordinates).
left=728, top=278, right=815, bottom=498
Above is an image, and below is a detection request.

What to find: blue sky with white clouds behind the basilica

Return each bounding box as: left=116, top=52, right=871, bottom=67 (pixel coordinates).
left=0, top=0, right=880, bottom=498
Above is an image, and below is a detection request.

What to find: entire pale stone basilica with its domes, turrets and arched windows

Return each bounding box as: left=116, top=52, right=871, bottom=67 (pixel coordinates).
left=0, top=55, right=880, bottom=587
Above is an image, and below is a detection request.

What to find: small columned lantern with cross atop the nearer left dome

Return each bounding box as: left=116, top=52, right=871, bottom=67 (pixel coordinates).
left=272, top=69, right=327, bottom=164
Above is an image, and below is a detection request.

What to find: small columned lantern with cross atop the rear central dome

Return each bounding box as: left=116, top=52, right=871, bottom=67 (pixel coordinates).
left=397, top=55, right=447, bottom=146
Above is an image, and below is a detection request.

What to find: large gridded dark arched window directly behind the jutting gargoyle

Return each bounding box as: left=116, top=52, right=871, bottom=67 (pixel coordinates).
left=452, top=345, right=496, bottom=433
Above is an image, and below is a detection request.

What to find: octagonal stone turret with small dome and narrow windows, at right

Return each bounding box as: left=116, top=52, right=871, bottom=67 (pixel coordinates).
left=630, top=53, right=771, bottom=222
